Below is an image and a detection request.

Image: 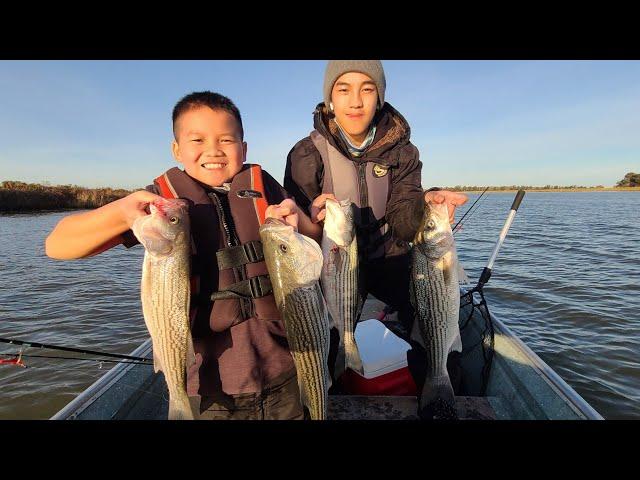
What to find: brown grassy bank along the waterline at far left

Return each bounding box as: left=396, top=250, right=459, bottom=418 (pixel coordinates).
left=0, top=181, right=131, bottom=212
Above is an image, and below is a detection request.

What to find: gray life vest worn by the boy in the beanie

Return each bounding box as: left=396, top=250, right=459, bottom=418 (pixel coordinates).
left=309, top=130, right=393, bottom=260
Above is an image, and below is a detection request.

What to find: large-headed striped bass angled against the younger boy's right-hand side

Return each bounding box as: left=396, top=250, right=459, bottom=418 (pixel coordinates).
left=260, top=218, right=331, bottom=420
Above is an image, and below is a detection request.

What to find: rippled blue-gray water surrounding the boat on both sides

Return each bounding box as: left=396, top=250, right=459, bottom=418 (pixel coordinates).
left=0, top=192, right=640, bottom=419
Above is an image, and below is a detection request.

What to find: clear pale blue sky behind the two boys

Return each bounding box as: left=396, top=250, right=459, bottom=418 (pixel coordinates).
left=0, top=60, right=640, bottom=189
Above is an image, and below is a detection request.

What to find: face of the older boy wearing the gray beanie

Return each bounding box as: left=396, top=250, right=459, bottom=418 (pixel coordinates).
left=331, top=72, right=378, bottom=144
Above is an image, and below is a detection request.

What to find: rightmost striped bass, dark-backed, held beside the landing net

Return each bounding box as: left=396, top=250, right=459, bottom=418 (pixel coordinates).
left=409, top=203, right=466, bottom=419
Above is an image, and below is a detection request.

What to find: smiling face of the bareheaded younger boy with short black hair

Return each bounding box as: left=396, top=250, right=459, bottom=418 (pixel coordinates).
left=171, top=106, right=247, bottom=187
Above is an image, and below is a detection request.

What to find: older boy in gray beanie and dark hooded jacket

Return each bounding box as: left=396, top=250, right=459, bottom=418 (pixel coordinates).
left=284, top=60, right=467, bottom=418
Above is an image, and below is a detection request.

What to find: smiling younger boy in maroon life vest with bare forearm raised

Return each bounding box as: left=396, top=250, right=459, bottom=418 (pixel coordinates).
left=46, top=92, right=322, bottom=419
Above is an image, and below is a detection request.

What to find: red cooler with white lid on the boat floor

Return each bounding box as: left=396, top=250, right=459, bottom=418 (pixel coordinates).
left=341, top=318, right=417, bottom=396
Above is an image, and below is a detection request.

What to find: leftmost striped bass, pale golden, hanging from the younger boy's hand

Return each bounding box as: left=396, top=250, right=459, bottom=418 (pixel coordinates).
left=132, top=200, right=195, bottom=420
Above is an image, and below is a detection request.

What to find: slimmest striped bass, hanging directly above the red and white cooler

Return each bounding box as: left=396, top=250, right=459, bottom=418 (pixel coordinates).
left=320, top=198, right=364, bottom=378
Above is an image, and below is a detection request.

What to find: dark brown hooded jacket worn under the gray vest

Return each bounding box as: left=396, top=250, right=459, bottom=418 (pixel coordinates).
left=284, top=103, right=424, bottom=257
